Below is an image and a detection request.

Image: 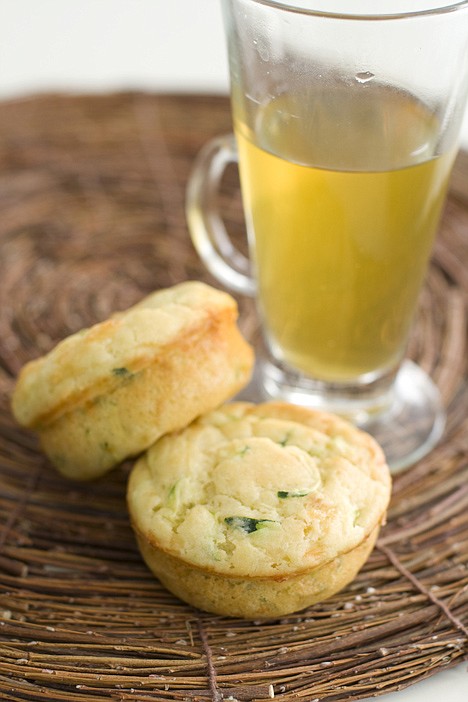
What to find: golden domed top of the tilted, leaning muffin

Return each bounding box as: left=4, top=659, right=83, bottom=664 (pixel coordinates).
left=12, top=281, right=237, bottom=428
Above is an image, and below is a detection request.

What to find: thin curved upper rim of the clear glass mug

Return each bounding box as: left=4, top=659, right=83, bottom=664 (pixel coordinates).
left=247, top=0, right=468, bottom=22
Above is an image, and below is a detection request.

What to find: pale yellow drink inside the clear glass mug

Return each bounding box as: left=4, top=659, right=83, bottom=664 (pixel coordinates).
left=234, top=84, right=454, bottom=388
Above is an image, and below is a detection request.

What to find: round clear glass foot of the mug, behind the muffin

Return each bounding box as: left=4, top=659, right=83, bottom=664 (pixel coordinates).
left=237, top=361, right=445, bottom=473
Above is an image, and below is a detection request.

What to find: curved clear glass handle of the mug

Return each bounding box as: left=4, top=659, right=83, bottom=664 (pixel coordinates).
left=186, top=134, right=257, bottom=297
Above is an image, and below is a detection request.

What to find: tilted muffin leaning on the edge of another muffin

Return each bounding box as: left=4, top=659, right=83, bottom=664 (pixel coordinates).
left=12, top=282, right=253, bottom=480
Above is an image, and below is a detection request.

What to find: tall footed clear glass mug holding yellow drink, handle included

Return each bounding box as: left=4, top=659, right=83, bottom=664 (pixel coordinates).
left=187, top=0, right=468, bottom=470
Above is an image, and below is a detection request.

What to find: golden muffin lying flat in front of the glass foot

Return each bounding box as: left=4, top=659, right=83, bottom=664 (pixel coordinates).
left=127, top=402, right=391, bottom=618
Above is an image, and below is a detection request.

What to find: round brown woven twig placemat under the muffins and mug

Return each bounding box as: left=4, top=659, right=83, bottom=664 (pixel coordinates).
left=0, top=94, right=468, bottom=702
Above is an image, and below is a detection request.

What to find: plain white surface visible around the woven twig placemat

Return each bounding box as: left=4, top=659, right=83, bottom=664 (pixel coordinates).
left=0, top=0, right=468, bottom=702
